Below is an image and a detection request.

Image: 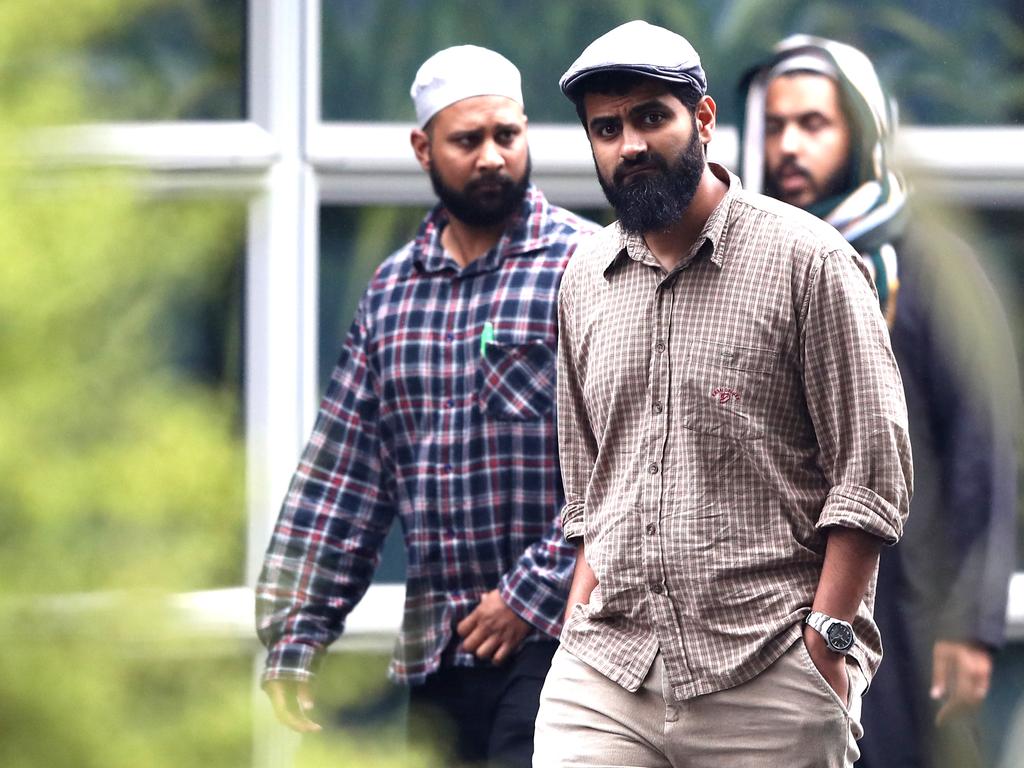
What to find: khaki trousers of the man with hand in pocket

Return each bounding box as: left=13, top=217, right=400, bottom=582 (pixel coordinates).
left=534, top=639, right=865, bottom=768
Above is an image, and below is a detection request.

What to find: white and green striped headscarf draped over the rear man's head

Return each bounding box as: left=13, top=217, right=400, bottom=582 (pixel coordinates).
left=740, top=35, right=906, bottom=325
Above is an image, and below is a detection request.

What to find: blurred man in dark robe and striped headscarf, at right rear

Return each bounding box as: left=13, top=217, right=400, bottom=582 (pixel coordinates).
left=740, top=35, right=1019, bottom=768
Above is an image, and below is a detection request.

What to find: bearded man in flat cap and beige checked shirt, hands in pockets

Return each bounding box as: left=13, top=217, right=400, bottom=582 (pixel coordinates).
left=534, top=22, right=911, bottom=768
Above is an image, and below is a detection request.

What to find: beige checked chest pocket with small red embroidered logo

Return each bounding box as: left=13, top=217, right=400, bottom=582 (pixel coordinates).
left=681, top=341, right=778, bottom=439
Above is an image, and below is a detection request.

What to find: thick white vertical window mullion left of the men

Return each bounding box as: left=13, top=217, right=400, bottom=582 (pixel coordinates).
left=246, top=0, right=319, bottom=768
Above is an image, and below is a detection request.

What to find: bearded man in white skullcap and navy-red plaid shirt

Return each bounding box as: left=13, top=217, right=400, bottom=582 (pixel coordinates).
left=256, top=45, right=595, bottom=766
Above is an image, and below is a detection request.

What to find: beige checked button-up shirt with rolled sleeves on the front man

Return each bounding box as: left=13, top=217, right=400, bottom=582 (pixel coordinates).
left=558, top=166, right=912, bottom=699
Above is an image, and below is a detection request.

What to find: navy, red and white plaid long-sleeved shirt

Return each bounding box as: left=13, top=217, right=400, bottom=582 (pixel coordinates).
left=256, top=187, right=596, bottom=683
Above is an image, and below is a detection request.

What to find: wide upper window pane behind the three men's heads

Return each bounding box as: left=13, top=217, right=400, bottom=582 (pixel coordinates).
left=323, top=0, right=1024, bottom=124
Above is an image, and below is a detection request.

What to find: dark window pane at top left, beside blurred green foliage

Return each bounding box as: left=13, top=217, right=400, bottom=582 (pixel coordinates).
left=73, top=0, right=246, bottom=121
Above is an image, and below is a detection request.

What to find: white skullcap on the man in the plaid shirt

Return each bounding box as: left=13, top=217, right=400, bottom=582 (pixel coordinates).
left=409, top=45, right=524, bottom=128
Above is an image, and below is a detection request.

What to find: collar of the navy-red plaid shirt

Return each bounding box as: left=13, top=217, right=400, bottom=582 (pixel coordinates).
left=407, top=184, right=556, bottom=274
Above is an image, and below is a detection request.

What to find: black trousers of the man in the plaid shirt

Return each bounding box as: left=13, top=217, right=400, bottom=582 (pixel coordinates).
left=409, top=640, right=558, bottom=768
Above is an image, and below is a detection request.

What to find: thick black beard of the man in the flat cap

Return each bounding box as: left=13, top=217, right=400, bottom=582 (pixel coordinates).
left=597, top=123, right=705, bottom=234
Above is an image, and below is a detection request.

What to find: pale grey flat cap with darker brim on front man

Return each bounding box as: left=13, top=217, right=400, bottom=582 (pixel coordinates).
left=558, top=20, right=708, bottom=98
